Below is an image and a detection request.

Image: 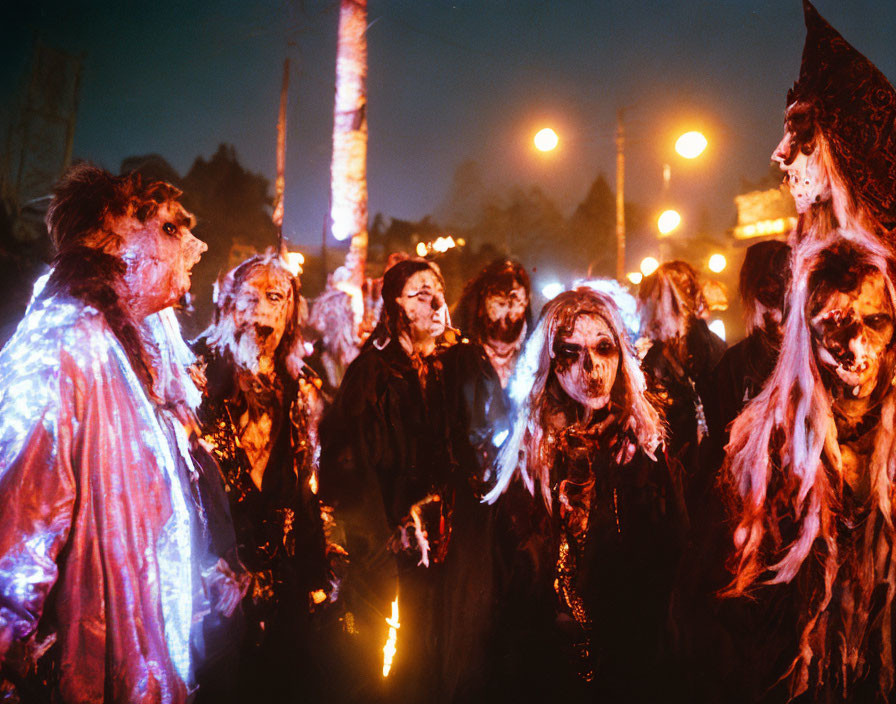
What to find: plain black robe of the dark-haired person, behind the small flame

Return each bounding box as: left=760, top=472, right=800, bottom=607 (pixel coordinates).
left=320, top=340, right=506, bottom=701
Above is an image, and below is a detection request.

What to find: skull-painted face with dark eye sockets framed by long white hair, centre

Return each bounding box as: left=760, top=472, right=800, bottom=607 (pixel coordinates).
left=553, top=313, right=619, bottom=410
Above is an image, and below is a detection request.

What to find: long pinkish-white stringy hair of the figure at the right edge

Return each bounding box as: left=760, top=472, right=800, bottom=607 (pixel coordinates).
left=723, top=227, right=896, bottom=696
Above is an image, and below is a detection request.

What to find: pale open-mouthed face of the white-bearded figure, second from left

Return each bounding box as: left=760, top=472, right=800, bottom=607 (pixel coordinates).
left=233, top=266, right=293, bottom=357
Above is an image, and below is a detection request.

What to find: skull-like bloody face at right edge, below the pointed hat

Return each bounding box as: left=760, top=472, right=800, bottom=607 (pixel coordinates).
left=812, top=273, right=893, bottom=398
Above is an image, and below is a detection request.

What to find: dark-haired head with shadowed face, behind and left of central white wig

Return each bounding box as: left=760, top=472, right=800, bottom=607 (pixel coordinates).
left=454, top=259, right=532, bottom=388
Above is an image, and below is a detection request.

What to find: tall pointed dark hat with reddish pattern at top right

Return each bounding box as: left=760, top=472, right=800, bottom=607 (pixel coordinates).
left=787, top=0, right=896, bottom=230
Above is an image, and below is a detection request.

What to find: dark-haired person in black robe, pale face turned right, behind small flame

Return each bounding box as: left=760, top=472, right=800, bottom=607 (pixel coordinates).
left=320, top=259, right=500, bottom=702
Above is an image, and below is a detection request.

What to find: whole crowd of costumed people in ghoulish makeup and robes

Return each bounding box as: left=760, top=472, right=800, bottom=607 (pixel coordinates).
left=0, top=1, right=896, bottom=704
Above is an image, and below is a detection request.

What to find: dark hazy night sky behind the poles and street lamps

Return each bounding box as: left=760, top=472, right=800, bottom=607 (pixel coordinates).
left=0, top=0, right=896, bottom=256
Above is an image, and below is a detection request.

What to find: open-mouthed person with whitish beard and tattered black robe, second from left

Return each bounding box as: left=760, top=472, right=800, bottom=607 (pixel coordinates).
left=194, top=250, right=329, bottom=702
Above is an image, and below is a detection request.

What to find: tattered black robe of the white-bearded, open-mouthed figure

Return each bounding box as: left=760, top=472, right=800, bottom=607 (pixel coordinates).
left=196, top=341, right=329, bottom=702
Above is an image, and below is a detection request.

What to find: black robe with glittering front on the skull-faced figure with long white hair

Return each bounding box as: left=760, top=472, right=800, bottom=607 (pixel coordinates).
left=496, top=413, right=687, bottom=702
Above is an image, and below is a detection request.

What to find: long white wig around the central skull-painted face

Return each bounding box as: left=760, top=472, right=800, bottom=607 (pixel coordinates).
left=484, top=287, right=664, bottom=509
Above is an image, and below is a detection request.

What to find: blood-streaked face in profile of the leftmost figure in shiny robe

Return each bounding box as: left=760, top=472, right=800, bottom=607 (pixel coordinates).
left=114, top=201, right=208, bottom=315
